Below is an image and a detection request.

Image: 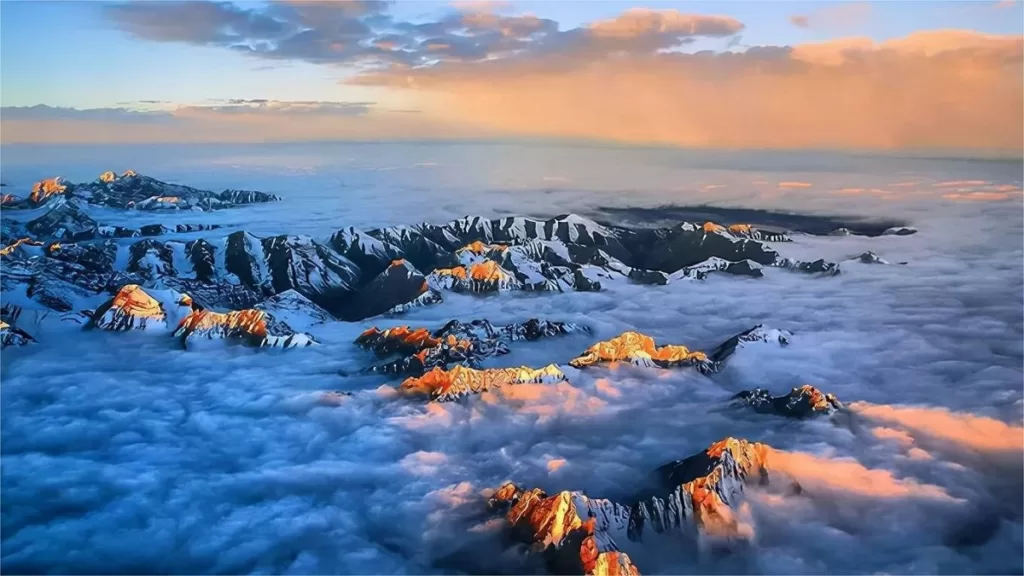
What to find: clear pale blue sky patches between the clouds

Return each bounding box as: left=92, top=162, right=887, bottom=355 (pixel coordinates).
left=0, top=0, right=1024, bottom=108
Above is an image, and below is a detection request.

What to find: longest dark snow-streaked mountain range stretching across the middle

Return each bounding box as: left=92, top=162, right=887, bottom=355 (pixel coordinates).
left=0, top=212, right=880, bottom=320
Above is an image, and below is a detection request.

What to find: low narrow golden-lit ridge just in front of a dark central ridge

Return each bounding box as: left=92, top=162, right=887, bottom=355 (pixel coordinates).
left=397, top=364, right=567, bottom=402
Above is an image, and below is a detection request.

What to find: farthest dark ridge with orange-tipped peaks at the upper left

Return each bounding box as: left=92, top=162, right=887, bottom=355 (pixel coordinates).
left=5, top=170, right=280, bottom=210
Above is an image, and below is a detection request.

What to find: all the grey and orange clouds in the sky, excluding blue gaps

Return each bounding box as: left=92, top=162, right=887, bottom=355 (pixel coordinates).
left=2, top=1, right=1024, bottom=153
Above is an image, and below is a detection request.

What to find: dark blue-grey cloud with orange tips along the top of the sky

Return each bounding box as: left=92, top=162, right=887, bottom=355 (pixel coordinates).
left=104, top=1, right=743, bottom=69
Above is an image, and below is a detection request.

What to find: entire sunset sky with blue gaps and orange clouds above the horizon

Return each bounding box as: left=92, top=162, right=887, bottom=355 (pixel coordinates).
left=0, top=0, right=1024, bottom=154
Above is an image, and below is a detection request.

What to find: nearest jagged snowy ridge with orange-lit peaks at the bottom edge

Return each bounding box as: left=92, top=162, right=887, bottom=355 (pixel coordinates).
left=488, top=438, right=771, bottom=574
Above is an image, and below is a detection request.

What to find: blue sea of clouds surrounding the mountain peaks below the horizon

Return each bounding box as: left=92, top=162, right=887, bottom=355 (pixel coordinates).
left=0, top=145, right=1024, bottom=574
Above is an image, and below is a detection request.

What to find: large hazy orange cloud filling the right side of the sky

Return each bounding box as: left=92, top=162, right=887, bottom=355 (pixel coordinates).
left=353, top=29, right=1024, bottom=152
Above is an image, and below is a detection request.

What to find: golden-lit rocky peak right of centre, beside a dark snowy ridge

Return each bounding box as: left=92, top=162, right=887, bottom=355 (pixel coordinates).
left=569, top=332, right=716, bottom=372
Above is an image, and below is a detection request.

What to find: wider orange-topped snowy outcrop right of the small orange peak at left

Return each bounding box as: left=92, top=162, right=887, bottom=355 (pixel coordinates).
left=174, top=308, right=317, bottom=348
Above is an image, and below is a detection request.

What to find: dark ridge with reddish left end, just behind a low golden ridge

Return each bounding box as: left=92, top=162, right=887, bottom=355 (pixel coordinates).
left=355, top=318, right=590, bottom=375
